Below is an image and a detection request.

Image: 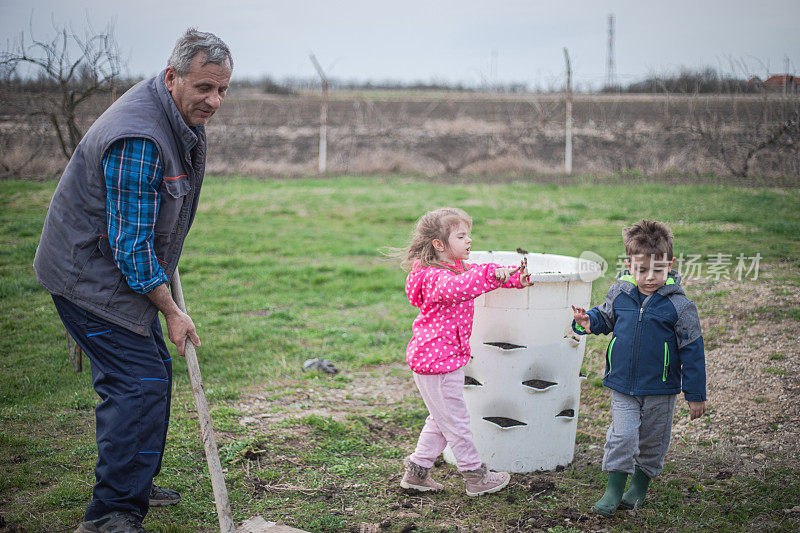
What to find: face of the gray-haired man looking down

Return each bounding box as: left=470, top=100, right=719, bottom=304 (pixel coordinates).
left=164, top=53, right=231, bottom=127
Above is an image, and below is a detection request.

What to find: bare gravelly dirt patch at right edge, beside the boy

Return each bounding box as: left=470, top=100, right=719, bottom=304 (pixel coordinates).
left=673, top=267, right=800, bottom=472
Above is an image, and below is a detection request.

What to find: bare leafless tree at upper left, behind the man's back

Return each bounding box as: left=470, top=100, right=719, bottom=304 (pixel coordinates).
left=0, top=21, right=121, bottom=159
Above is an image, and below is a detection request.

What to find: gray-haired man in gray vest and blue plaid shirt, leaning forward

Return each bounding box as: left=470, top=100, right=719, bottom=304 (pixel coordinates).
left=34, top=29, right=233, bottom=532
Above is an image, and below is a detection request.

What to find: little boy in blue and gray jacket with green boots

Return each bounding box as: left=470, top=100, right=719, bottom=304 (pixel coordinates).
left=572, top=220, right=706, bottom=516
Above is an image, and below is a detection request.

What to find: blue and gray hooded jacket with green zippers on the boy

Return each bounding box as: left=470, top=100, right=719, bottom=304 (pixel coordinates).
left=572, top=270, right=706, bottom=402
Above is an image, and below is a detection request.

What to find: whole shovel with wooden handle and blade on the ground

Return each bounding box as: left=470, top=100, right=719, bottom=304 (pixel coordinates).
left=171, top=267, right=305, bottom=533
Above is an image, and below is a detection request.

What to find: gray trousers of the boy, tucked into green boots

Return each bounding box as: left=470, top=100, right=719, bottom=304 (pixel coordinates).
left=603, top=390, right=677, bottom=478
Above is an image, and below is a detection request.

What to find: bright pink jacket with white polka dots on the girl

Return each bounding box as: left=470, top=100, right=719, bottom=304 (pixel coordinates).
left=406, top=261, right=522, bottom=374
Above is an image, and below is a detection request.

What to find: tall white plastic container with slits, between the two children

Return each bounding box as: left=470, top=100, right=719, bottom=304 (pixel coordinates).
left=444, top=252, right=602, bottom=472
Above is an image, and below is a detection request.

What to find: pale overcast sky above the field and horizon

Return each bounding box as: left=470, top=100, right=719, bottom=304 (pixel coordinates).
left=0, top=0, right=800, bottom=88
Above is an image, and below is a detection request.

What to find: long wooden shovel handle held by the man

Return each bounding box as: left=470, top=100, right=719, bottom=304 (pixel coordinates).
left=170, top=267, right=236, bottom=533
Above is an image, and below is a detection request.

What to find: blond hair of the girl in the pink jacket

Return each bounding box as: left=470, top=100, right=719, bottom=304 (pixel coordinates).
left=399, top=207, right=472, bottom=271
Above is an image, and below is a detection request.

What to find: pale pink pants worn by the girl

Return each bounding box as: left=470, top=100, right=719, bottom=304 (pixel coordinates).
left=411, top=368, right=481, bottom=472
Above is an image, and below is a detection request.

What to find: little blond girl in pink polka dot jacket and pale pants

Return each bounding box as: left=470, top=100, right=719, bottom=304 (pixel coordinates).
left=400, top=207, right=531, bottom=496
